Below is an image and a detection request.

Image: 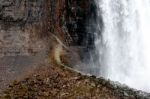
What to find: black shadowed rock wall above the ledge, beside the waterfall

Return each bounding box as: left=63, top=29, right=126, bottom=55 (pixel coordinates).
left=65, top=0, right=96, bottom=46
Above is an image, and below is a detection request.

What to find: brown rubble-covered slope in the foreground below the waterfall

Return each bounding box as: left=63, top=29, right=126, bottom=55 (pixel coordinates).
left=0, top=63, right=150, bottom=99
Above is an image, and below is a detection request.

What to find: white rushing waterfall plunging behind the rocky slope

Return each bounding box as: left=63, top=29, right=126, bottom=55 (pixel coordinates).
left=95, top=0, right=150, bottom=92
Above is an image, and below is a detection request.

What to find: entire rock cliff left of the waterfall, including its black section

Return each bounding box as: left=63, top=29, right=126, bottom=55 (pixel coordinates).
left=0, top=0, right=95, bottom=91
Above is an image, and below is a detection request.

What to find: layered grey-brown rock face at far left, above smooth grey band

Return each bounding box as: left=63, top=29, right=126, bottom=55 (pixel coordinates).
left=0, top=0, right=45, bottom=56
